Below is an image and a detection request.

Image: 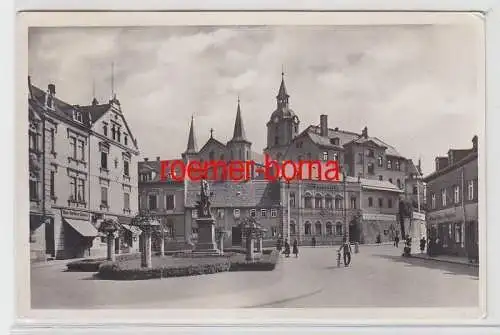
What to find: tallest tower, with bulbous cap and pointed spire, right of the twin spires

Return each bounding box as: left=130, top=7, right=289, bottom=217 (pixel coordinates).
left=264, top=72, right=300, bottom=160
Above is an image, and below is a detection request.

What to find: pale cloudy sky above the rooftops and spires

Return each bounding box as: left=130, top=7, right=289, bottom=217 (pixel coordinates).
left=29, top=25, right=482, bottom=173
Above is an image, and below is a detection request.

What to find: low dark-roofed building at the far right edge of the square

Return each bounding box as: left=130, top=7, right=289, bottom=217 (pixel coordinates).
left=424, top=136, right=478, bottom=259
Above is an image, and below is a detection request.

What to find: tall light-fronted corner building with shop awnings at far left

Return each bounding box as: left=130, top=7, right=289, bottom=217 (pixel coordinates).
left=28, top=82, right=139, bottom=259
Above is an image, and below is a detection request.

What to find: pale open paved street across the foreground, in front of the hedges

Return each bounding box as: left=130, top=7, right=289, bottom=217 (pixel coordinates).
left=31, top=245, right=479, bottom=308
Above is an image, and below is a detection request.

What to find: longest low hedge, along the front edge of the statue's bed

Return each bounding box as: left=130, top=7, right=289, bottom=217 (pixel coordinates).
left=97, top=258, right=231, bottom=280
